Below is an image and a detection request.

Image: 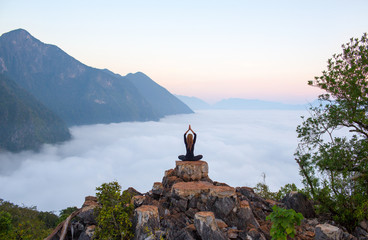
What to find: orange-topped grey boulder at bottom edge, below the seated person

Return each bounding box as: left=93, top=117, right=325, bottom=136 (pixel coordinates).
left=194, top=212, right=227, bottom=240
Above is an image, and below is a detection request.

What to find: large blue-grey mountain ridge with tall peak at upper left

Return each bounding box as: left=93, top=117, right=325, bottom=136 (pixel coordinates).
left=0, top=29, right=192, bottom=126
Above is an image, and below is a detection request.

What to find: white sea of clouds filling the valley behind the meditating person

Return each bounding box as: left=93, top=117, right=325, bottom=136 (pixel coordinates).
left=0, top=110, right=307, bottom=211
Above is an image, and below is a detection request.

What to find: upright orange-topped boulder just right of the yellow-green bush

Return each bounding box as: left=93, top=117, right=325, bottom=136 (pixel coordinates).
left=133, top=205, right=160, bottom=240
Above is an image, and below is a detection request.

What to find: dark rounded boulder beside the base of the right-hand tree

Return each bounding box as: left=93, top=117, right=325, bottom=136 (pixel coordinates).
left=281, top=191, right=316, bottom=218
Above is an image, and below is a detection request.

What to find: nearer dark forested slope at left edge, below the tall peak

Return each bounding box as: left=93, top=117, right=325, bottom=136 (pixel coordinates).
left=0, top=74, right=70, bottom=152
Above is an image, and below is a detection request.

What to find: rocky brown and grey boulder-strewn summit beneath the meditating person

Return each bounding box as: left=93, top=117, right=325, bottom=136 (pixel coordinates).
left=47, top=161, right=368, bottom=240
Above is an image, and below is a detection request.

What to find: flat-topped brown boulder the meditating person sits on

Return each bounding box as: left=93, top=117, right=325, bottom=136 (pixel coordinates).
left=175, top=161, right=208, bottom=182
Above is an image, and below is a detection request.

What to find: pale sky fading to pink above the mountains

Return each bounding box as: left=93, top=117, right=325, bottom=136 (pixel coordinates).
left=0, top=0, right=368, bottom=103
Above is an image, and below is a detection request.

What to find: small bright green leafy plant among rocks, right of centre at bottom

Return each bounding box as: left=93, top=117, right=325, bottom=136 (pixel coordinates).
left=266, top=205, right=304, bottom=240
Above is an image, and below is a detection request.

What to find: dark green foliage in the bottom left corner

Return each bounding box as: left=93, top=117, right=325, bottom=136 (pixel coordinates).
left=0, top=199, right=58, bottom=240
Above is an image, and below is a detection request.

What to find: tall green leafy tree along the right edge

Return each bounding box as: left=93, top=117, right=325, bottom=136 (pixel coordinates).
left=295, top=34, right=368, bottom=230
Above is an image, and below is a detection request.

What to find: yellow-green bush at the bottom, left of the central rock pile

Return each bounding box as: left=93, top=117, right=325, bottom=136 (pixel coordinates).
left=95, top=181, right=134, bottom=240
